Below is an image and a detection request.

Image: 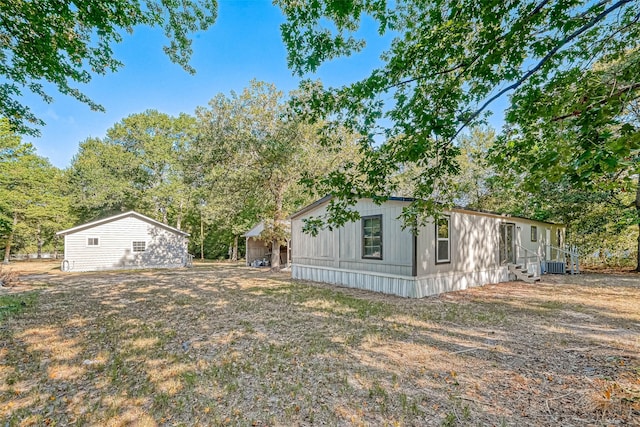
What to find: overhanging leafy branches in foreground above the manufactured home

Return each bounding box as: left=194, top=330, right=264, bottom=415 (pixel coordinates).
left=276, top=0, right=640, bottom=227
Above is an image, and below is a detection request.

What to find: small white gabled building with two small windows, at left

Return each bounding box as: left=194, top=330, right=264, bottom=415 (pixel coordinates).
left=56, top=211, right=191, bottom=271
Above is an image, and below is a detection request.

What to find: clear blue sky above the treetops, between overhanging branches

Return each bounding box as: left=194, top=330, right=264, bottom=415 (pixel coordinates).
left=24, top=0, right=387, bottom=168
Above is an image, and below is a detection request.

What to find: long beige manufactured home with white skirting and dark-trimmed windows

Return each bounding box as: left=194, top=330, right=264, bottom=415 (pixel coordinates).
left=291, top=196, right=565, bottom=298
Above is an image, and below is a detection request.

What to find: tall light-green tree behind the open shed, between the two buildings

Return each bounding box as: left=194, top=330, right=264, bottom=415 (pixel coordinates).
left=196, top=81, right=357, bottom=268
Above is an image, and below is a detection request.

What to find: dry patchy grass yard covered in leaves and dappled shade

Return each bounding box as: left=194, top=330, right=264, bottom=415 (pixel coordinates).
left=0, top=263, right=640, bottom=426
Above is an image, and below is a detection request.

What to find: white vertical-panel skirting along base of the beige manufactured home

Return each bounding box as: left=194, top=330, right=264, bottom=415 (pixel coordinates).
left=291, top=264, right=509, bottom=298
